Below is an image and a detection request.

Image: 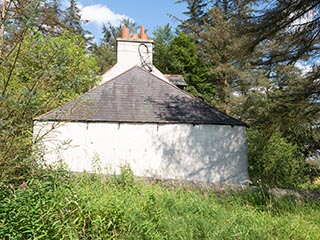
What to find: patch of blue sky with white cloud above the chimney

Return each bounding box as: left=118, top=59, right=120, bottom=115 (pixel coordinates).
left=77, top=0, right=187, bottom=40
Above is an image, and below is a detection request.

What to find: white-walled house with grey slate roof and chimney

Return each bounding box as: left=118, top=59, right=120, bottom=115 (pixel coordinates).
left=33, top=27, right=248, bottom=184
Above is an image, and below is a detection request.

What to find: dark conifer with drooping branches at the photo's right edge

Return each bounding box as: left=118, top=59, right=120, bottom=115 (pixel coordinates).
left=241, top=0, right=320, bottom=157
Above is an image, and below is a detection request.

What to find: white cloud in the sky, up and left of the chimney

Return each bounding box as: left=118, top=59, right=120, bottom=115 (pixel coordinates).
left=79, top=4, right=128, bottom=26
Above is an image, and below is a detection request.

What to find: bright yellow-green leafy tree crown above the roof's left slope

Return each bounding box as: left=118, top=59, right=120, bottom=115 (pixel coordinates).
left=3, top=31, right=97, bottom=104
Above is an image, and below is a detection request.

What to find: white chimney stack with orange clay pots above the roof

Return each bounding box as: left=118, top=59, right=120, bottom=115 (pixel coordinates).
left=117, top=26, right=154, bottom=71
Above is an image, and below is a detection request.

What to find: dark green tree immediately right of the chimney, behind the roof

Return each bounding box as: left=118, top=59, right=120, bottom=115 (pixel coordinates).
left=154, top=24, right=215, bottom=105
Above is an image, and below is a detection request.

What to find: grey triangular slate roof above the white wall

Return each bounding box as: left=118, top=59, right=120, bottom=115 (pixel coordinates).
left=35, top=66, right=245, bottom=125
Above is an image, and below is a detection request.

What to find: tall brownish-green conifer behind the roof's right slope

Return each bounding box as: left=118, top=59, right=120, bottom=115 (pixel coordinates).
left=180, top=0, right=255, bottom=113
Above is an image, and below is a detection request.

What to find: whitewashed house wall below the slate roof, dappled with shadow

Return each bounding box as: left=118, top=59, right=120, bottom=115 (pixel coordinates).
left=34, top=121, right=248, bottom=184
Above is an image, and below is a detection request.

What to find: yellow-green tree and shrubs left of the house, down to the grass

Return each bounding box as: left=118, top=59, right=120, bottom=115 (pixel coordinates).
left=0, top=30, right=97, bottom=185
